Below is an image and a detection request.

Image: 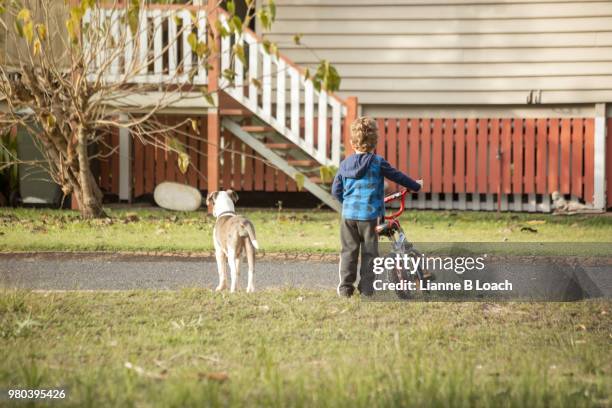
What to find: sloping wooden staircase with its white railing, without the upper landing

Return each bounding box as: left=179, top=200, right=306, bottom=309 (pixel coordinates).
left=219, top=10, right=354, bottom=211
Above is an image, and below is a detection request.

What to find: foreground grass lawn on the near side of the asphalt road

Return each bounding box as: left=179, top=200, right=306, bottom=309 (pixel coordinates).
left=0, top=289, right=612, bottom=407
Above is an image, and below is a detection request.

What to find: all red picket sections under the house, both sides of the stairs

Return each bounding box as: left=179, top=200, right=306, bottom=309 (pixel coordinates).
left=99, top=116, right=612, bottom=207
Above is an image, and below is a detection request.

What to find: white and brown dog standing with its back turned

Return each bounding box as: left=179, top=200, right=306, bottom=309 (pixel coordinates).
left=206, top=190, right=259, bottom=292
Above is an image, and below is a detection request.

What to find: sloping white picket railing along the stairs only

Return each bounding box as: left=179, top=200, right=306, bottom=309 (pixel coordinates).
left=220, top=13, right=346, bottom=166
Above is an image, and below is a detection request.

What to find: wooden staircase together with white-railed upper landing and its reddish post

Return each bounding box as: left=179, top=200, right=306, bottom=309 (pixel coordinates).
left=84, top=3, right=357, bottom=210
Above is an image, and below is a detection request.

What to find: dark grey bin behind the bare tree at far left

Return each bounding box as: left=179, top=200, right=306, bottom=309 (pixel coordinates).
left=17, top=124, right=62, bottom=206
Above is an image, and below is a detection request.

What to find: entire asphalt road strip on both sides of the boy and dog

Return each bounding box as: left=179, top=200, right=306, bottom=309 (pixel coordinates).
left=0, top=253, right=612, bottom=300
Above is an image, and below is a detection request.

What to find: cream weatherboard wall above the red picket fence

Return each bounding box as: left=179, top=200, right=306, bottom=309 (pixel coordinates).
left=270, top=0, right=612, bottom=105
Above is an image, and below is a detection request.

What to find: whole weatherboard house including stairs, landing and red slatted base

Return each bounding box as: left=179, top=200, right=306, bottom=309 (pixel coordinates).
left=2, top=0, right=612, bottom=212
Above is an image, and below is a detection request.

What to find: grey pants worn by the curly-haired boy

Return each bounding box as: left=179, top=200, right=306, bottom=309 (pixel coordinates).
left=338, top=218, right=378, bottom=295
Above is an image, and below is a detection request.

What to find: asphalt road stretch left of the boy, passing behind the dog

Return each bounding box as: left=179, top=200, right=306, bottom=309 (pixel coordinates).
left=0, top=254, right=338, bottom=290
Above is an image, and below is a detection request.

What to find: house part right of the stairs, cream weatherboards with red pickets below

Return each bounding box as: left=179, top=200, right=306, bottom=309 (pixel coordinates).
left=270, top=0, right=612, bottom=211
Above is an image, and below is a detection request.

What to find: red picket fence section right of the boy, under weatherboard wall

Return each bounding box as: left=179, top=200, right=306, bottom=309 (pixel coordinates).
left=376, top=118, right=594, bottom=202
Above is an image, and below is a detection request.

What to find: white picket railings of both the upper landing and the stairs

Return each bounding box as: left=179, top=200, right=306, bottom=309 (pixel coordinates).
left=83, top=6, right=346, bottom=166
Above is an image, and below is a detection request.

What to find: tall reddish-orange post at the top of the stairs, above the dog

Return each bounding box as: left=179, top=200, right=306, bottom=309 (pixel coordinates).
left=206, top=1, right=221, bottom=212
